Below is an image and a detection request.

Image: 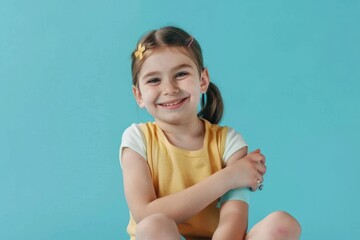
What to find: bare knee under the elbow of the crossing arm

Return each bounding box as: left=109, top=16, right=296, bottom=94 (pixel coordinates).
left=136, top=214, right=180, bottom=240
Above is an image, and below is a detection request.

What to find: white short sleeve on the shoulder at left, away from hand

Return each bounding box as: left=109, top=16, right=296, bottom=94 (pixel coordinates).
left=119, top=124, right=146, bottom=165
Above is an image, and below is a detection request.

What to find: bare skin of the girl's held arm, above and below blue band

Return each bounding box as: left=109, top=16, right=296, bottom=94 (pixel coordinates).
left=212, top=147, right=249, bottom=240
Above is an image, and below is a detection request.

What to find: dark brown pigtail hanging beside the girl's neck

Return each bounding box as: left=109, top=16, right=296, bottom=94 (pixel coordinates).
left=198, top=82, right=224, bottom=124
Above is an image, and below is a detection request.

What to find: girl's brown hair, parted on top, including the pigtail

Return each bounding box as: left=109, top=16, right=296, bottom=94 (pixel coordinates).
left=131, top=26, right=224, bottom=124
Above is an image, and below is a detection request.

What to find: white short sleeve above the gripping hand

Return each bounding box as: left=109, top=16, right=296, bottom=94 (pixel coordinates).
left=223, top=127, right=247, bottom=164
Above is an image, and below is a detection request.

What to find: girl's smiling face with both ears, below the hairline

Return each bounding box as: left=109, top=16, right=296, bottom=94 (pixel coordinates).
left=133, top=47, right=209, bottom=124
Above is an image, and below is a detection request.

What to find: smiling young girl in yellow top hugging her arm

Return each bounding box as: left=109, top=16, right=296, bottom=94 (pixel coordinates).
left=120, top=27, right=301, bottom=240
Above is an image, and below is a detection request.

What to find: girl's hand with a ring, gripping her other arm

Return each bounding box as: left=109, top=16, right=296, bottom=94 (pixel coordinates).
left=225, top=149, right=266, bottom=191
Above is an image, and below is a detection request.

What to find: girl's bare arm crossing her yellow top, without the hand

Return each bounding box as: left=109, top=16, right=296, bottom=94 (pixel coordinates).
left=122, top=148, right=236, bottom=223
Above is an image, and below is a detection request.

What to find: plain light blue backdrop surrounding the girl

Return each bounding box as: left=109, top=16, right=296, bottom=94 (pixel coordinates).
left=0, top=0, right=360, bottom=240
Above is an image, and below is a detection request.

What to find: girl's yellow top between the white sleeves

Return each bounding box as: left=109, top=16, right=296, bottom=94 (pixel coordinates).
left=127, top=120, right=227, bottom=240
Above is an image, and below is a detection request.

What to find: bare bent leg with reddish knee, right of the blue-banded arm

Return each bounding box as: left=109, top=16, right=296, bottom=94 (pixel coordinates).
left=245, top=211, right=301, bottom=240
